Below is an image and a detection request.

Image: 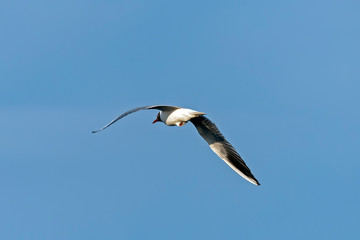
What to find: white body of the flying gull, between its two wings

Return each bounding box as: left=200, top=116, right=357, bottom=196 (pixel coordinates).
left=160, top=108, right=205, bottom=126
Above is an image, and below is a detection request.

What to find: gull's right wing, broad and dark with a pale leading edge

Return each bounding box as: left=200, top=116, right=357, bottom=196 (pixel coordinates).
left=190, top=116, right=260, bottom=185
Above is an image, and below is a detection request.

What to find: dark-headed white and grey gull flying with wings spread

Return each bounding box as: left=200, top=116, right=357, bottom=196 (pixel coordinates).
left=92, top=105, right=260, bottom=185
